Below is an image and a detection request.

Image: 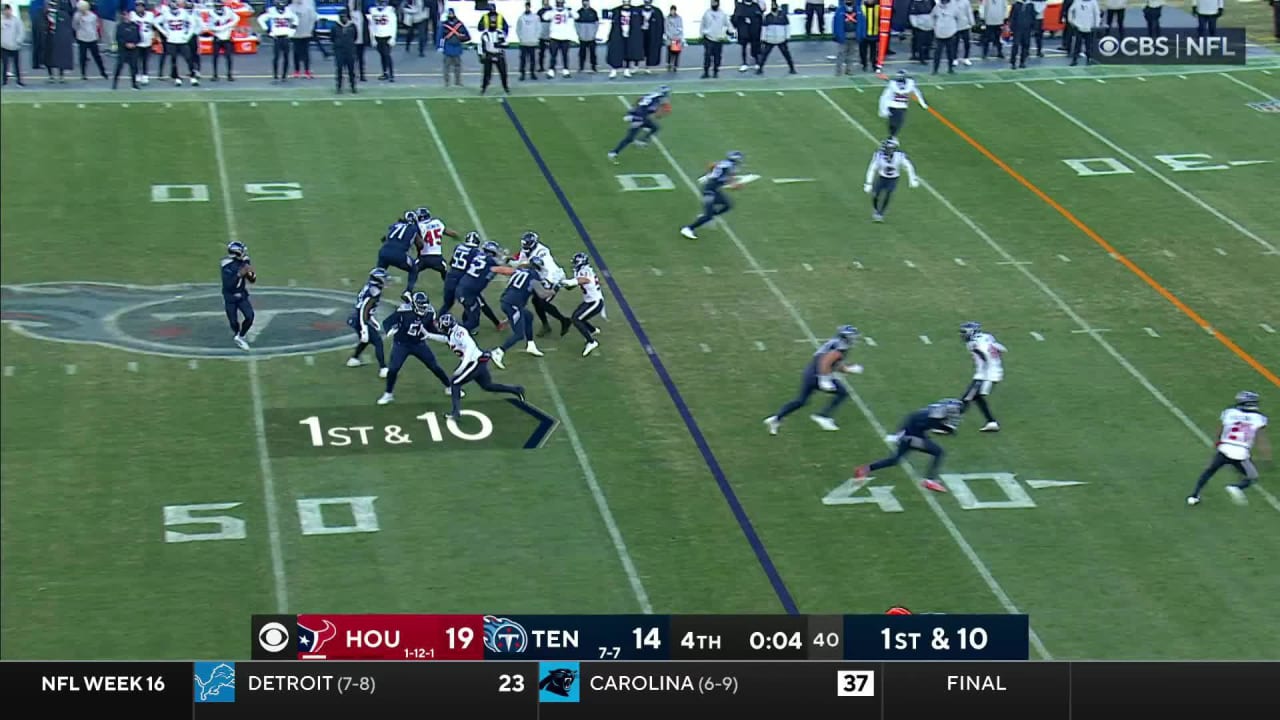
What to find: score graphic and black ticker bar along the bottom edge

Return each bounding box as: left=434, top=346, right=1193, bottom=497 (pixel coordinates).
left=0, top=609, right=1280, bottom=720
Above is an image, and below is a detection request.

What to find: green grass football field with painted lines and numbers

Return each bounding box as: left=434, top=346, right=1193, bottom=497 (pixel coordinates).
left=0, top=68, right=1280, bottom=659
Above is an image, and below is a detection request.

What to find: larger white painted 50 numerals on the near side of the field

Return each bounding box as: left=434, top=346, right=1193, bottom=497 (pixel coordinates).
left=164, top=496, right=380, bottom=542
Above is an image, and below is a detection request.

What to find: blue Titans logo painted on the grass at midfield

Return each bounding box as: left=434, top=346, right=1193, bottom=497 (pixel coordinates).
left=0, top=282, right=355, bottom=360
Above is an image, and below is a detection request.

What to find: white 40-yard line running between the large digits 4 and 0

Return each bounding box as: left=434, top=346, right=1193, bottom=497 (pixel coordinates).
left=618, top=91, right=1052, bottom=660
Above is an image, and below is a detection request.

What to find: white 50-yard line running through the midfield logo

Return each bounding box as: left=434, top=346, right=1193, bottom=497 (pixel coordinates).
left=209, top=102, right=289, bottom=612
